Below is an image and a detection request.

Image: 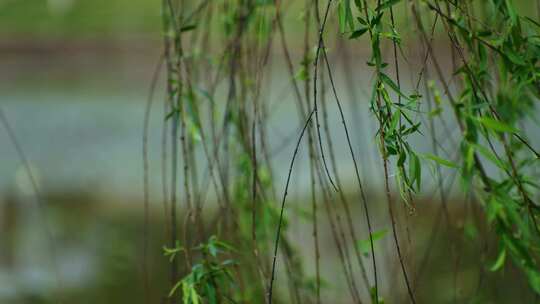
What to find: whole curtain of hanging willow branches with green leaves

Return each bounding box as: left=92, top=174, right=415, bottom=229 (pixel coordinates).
left=154, top=0, right=540, bottom=304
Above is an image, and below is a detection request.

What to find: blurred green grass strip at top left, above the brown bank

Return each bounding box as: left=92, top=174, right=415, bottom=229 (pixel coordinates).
left=0, top=0, right=161, bottom=40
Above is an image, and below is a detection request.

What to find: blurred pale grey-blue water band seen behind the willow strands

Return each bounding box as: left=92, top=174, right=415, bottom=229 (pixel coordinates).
left=0, top=60, right=388, bottom=201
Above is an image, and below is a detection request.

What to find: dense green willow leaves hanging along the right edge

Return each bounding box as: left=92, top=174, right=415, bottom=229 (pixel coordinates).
left=450, top=0, right=540, bottom=293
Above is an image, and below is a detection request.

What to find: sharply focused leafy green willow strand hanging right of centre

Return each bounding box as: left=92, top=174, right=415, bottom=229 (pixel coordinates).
left=338, top=0, right=422, bottom=202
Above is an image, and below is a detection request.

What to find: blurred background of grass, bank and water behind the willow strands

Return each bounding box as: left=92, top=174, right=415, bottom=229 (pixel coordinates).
left=0, top=0, right=538, bottom=303
